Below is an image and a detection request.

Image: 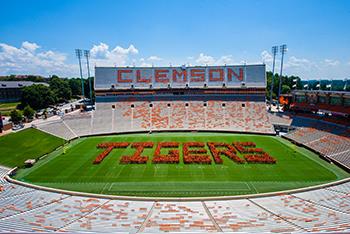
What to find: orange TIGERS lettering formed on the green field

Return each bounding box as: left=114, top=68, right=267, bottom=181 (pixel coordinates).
left=93, top=142, right=276, bottom=164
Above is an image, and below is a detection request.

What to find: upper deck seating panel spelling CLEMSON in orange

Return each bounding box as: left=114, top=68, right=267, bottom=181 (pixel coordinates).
left=95, top=64, right=266, bottom=90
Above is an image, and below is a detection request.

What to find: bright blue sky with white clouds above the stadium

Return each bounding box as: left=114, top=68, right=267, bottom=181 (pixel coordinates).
left=0, top=0, right=350, bottom=79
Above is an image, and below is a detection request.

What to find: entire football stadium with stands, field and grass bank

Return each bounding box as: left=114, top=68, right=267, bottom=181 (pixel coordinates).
left=0, top=64, right=350, bottom=233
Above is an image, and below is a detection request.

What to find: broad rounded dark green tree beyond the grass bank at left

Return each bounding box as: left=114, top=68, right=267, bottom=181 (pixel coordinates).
left=21, top=85, right=57, bottom=110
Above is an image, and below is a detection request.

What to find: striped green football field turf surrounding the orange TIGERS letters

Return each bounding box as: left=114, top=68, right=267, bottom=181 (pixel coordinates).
left=15, top=133, right=348, bottom=197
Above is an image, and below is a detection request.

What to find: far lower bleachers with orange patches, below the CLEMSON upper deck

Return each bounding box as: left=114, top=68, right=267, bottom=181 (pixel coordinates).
left=37, top=101, right=274, bottom=139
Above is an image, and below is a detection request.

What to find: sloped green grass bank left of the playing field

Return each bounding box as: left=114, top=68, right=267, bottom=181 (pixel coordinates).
left=0, top=128, right=64, bottom=167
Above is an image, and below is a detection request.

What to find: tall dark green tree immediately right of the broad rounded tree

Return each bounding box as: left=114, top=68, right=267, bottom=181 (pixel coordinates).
left=49, top=75, right=72, bottom=102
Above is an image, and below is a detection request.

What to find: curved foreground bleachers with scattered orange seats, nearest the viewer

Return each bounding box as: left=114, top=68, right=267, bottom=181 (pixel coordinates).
left=0, top=167, right=350, bottom=233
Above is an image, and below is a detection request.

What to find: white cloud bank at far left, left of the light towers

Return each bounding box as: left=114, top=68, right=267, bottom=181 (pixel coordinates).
left=0, top=41, right=76, bottom=76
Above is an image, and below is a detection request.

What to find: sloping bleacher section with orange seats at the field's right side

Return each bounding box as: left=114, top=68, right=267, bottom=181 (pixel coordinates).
left=285, top=128, right=350, bottom=168
